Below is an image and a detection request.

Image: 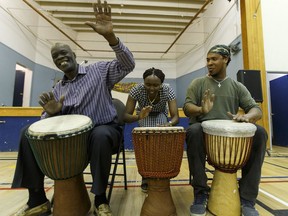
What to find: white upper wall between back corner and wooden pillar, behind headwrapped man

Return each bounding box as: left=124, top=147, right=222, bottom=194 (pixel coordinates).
left=177, top=0, right=241, bottom=77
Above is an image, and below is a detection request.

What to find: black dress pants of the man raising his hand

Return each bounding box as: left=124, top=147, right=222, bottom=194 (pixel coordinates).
left=12, top=122, right=122, bottom=195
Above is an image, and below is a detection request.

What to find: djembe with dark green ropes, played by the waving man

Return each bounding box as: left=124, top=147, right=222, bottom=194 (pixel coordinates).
left=26, top=115, right=93, bottom=216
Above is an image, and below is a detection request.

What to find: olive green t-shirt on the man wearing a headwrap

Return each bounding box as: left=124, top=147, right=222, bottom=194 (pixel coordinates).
left=183, top=76, right=260, bottom=123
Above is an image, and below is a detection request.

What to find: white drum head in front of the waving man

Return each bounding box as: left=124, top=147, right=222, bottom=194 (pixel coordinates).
left=27, top=114, right=92, bottom=138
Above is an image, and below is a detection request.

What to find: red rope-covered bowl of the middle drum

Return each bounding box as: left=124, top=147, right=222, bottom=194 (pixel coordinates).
left=132, top=129, right=185, bottom=178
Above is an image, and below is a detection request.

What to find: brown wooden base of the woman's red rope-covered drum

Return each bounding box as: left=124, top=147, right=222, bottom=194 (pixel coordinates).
left=140, top=179, right=177, bottom=216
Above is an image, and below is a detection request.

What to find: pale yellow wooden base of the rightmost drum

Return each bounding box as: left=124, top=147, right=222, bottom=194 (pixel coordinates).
left=208, top=170, right=240, bottom=216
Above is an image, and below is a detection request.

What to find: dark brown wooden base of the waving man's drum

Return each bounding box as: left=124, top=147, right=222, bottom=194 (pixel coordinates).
left=53, top=174, right=91, bottom=216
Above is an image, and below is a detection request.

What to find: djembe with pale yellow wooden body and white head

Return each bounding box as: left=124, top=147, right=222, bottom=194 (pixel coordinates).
left=202, top=120, right=256, bottom=216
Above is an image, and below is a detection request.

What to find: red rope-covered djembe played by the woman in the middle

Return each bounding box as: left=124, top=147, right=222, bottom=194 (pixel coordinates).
left=132, top=127, right=185, bottom=216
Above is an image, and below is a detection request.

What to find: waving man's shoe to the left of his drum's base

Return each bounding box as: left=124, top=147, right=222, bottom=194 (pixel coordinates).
left=13, top=200, right=51, bottom=216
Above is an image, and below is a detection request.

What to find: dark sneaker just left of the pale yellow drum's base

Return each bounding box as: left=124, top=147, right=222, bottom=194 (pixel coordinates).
left=190, top=194, right=208, bottom=216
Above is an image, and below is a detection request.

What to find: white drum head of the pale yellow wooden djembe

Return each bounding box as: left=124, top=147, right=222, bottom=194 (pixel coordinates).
left=201, top=120, right=257, bottom=137
